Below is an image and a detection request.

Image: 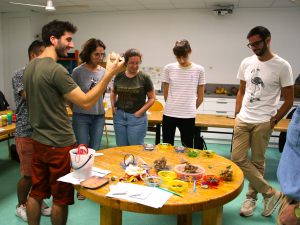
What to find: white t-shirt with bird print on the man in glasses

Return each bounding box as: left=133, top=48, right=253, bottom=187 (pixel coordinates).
left=237, top=55, right=294, bottom=123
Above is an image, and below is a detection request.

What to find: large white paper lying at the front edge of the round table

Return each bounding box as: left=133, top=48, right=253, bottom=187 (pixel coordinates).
left=106, top=182, right=173, bottom=208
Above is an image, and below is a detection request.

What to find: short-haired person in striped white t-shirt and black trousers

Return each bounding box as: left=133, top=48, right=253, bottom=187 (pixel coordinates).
left=162, top=39, right=205, bottom=148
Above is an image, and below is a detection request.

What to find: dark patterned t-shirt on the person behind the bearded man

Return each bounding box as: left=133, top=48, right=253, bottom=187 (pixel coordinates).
left=12, top=67, right=33, bottom=137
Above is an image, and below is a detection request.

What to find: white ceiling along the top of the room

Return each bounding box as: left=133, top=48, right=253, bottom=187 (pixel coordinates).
left=0, top=0, right=298, bottom=14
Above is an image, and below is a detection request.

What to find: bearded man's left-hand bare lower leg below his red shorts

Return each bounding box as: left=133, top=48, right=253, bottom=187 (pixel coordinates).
left=26, top=197, right=43, bottom=225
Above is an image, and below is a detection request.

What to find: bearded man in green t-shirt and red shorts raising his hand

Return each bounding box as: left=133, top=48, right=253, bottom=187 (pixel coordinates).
left=23, top=20, right=124, bottom=224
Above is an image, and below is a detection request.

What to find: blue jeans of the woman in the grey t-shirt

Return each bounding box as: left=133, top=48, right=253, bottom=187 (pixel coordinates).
left=72, top=113, right=105, bottom=151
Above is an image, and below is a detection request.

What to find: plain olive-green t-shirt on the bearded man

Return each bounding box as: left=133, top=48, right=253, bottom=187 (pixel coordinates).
left=23, top=57, right=77, bottom=147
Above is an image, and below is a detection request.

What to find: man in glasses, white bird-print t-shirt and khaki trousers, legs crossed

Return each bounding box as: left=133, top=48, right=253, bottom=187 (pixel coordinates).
left=231, top=26, right=294, bottom=216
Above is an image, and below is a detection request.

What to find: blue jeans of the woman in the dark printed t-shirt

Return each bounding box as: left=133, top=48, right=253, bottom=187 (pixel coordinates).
left=113, top=109, right=148, bottom=147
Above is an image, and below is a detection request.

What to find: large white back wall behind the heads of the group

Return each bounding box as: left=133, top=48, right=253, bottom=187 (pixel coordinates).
left=49, top=8, right=300, bottom=84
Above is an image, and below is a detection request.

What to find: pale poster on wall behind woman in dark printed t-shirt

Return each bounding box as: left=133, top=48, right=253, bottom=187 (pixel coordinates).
left=107, top=67, right=163, bottom=91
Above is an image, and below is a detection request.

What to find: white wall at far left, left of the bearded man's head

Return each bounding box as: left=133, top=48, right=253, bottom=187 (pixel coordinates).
left=0, top=11, right=47, bottom=109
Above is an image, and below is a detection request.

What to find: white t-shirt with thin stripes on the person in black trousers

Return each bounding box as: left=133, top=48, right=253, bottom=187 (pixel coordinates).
left=162, top=63, right=205, bottom=118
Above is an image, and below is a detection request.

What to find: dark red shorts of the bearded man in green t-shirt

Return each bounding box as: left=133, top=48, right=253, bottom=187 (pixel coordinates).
left=29, top=140, right=76, bottom=205
